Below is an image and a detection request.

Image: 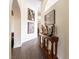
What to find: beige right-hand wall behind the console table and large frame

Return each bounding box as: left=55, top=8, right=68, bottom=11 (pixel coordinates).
left=41, top=0, right=69, bottom=59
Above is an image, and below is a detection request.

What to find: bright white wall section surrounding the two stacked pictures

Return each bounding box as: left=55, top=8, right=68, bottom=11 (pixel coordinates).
left=21, top=0, right=39, bottom=43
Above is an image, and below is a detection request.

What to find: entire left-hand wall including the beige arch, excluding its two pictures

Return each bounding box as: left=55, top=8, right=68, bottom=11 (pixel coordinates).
left=10, top=0, right=40, bottom=48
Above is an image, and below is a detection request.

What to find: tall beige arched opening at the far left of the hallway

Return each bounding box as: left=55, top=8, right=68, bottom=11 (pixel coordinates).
left=10, top=0, right=21, bottom=48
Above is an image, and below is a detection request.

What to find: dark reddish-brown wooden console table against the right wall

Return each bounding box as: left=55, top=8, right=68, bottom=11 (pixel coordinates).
left=39, top=34, right=59, bottom=59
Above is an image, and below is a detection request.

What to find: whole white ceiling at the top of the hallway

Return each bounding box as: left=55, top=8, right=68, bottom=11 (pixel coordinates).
left=26, top=0, right=58, bottom=11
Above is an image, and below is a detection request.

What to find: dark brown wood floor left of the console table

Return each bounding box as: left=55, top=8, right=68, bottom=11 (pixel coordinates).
left=12, top=39, right=47, bottom=59
